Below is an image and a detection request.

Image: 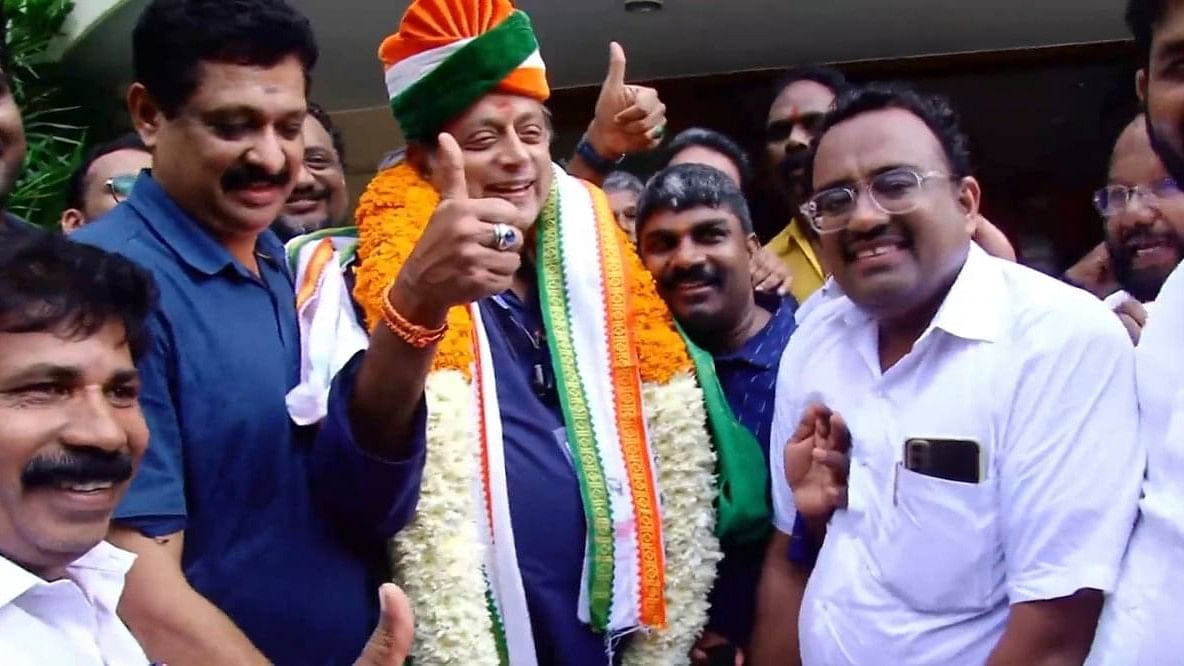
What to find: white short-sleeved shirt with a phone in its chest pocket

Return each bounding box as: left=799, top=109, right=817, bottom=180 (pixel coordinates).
left=770, top=245, right=1143, bottom=666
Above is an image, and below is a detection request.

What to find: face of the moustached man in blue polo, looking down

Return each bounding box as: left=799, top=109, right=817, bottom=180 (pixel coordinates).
left=129, top=56, right=307, bottom=236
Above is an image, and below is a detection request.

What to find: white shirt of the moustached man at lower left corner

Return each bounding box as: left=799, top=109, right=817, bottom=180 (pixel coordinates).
left=0, top=542, right=148, bottom=666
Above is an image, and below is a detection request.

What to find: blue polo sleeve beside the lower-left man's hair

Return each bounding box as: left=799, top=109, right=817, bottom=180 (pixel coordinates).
left=114, top=312, right=188, bottom=537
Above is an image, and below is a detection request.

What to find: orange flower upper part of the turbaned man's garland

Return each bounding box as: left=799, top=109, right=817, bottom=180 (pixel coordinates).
left=354, top=162, right=691, bottom=384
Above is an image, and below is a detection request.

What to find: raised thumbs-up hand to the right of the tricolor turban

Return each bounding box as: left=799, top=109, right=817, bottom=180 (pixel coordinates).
left=587, top=41, right=665, bottom=159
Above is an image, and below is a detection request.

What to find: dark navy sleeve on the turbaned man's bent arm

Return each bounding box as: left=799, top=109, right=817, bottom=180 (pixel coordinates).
left=310, top=352, right=427, bottom=539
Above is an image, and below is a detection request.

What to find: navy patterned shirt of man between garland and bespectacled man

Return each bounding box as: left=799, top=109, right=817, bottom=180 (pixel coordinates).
left=708, top=294, right=797, bottom=647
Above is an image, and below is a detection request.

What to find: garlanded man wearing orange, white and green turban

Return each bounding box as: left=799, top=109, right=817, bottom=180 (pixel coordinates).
left=285, top=0, right=770, bottom=666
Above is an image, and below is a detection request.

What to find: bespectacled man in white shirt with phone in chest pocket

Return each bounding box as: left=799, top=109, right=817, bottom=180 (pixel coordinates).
left=762, top=85, right=1143, bottom=666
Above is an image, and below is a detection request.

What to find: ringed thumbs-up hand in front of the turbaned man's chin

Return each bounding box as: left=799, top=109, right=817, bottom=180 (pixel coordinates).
left=391, top=133, right=528, bottom=327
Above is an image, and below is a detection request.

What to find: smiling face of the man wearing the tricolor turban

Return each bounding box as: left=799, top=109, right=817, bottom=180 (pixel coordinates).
left=429, top=92, right=552, bottom=226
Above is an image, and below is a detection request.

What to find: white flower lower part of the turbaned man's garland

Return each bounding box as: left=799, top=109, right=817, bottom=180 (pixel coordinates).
left=392, top=371, right=722, bottom=666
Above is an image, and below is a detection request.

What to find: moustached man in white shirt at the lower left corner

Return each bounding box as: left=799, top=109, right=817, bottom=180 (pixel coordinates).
left=0, top=231, right=154, bottom=666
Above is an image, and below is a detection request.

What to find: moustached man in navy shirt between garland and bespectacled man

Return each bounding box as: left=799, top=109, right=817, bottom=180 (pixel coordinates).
left=637, top=164, right=794, bottom=660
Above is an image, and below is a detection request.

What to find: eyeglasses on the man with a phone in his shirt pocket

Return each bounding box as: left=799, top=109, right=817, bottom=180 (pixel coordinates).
left=802, top=168, right=951, bottom=233
